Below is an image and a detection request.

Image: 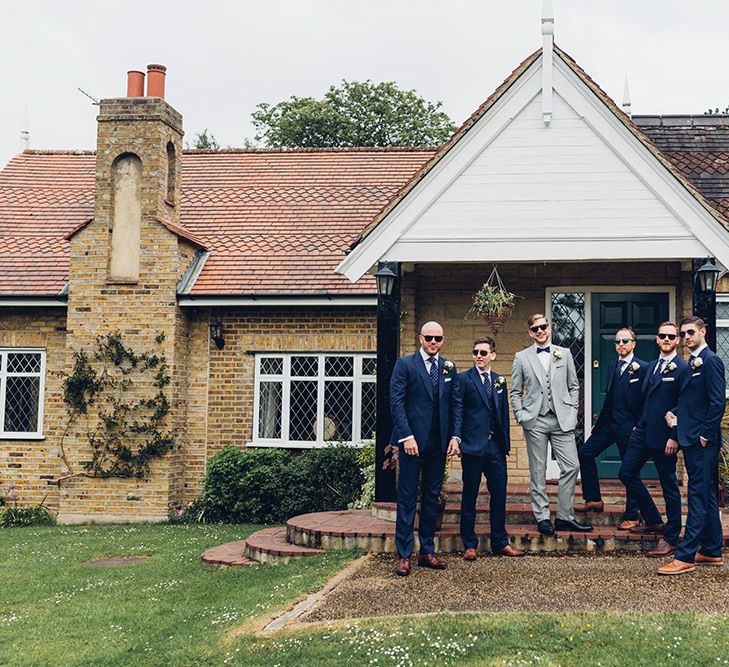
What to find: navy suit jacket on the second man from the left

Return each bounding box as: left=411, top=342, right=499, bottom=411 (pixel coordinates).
left=453, top=366, right=511, bottom=455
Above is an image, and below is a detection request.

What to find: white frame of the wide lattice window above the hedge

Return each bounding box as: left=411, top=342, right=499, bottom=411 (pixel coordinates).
left=248, top=351, right=376, bottom=449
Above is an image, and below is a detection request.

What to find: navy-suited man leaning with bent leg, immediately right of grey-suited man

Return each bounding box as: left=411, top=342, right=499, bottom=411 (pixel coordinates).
left=575, top=327, right=648, bottom=530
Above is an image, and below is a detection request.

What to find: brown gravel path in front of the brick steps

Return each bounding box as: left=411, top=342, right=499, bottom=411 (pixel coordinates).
left=299, top=555, right=729, bottom=622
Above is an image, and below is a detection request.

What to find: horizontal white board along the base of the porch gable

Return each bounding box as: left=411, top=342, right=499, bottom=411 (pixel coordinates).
left=388, top=237, right=706, bottom=263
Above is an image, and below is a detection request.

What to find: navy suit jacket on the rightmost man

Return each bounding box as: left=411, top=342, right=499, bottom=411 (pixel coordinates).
left=672, top=347, right=726, bottom=447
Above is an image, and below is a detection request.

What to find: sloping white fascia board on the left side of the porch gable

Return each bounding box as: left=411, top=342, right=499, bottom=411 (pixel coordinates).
left=335, top=56, right=542, bottom=282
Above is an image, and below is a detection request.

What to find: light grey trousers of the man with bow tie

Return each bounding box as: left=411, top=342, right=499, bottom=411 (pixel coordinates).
left=524, top=412, right=580, bottom=521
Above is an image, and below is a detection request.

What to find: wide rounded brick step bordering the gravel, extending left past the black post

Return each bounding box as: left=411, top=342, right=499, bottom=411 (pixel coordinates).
left=286, top=510, right=729, bottom=553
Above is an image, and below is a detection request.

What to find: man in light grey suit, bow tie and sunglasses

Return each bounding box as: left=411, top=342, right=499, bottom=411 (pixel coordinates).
left=510, top=313, right=592, bottom=535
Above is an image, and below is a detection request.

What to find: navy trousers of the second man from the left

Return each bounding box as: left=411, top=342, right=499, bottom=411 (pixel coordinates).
left=461, top=440, right=509, bottom=553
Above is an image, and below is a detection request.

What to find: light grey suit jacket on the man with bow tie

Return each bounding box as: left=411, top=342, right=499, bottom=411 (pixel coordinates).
left=509, top=343, right=580, bottom=431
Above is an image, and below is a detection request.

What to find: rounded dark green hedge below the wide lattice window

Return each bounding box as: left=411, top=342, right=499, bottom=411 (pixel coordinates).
left=201, top=445, right=364, bottom=523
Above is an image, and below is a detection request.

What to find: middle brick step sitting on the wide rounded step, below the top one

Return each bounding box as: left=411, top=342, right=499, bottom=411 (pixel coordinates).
left=372, top=498, right=686, bottom=526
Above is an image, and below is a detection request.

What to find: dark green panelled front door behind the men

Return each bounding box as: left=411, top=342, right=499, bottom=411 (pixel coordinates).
left=591, top=292, right=668, bottom=479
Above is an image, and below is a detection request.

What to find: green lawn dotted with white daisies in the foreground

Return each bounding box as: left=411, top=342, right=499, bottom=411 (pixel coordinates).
left=0, top=525, right=729, bottom=667
